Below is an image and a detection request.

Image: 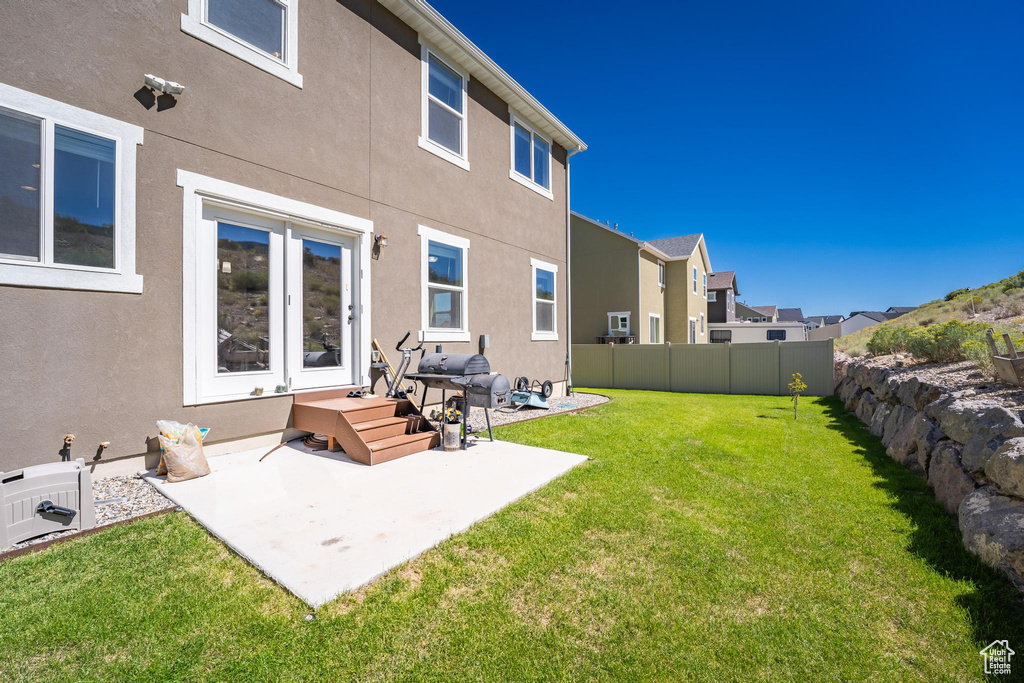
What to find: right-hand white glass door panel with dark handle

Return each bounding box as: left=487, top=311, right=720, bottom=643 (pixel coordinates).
left=288, top=224, right=358, bottom=389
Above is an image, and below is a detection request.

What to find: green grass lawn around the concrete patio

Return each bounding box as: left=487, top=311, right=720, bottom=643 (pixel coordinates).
left=0, top=391, right=1024, bottom=681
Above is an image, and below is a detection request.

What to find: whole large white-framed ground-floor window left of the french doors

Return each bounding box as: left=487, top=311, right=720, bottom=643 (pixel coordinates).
left=0, top=83, right=143, bottom=294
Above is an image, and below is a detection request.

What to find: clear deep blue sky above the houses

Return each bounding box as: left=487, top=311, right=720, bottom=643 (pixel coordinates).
left=433, top=0, right=1024, bottom=314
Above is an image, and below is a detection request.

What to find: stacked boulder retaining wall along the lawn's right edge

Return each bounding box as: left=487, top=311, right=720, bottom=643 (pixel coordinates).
left=836, top=359, right=1024, bottom=591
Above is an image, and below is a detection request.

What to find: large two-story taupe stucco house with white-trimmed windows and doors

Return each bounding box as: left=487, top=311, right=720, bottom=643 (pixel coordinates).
left=0, top=0, right=586, bottom=470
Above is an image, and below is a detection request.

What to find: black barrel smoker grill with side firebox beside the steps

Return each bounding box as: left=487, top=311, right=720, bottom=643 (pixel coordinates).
left=406, top=347, right=512, bottom=449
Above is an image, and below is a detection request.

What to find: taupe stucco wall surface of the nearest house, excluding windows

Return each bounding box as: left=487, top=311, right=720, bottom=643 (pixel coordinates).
left=0, top=0, right=567, bottom=470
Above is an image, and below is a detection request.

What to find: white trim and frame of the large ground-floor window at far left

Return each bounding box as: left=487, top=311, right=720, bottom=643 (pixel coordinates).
left=0, top=83, right=143, bottom=294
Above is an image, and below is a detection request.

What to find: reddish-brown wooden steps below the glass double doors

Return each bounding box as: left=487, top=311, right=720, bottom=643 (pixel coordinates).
left=292, top=392, right=440, bottom=465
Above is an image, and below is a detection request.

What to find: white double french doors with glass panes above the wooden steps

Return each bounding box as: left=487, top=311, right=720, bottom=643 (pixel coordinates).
left=197, top=203, right=358, bottom=398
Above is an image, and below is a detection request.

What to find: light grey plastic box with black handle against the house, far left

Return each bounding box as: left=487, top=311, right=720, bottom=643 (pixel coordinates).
left=0, top=458, right=96, bottom=551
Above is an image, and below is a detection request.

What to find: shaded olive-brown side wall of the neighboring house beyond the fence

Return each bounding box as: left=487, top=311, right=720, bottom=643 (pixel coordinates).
left=569, top=216, right=638, bottom=344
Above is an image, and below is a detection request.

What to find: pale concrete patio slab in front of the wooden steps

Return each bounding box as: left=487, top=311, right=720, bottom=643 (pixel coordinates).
left=146, top=440, right=587, bottom=607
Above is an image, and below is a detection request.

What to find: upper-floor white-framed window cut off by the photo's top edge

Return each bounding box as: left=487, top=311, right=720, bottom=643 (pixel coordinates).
left=181, top=0, right=302, bottom=88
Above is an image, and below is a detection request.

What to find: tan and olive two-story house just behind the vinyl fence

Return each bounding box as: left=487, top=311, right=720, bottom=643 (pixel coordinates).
left=569, top=211, right=711, bottom=344
